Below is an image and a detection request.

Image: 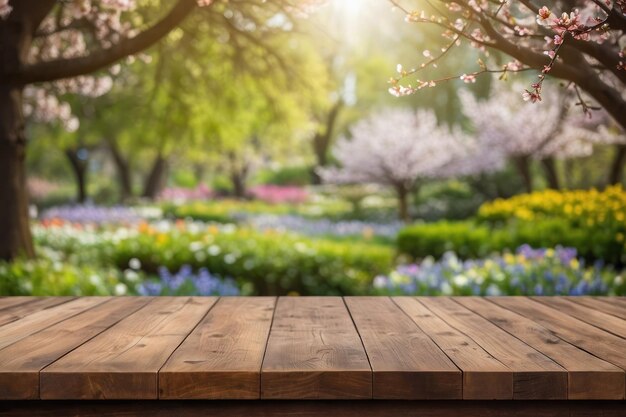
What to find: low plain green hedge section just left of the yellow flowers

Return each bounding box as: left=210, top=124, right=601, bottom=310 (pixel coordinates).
left=397, top=220, right=493, bottom=258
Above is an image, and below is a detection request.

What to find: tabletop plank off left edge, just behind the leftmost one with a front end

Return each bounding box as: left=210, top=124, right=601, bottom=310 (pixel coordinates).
left=0, top=297, right=110, bottom=349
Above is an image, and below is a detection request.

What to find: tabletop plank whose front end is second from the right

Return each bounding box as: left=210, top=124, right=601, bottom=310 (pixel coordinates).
left=417, top=297, right=567, bottom=400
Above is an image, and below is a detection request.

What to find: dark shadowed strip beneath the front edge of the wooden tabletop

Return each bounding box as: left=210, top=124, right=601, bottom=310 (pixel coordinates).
left=2, top=400, right=626, bottom=417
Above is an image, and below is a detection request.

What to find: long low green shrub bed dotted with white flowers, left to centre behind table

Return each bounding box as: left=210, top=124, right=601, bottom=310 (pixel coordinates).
left=34, top=221, right=393, bottom=295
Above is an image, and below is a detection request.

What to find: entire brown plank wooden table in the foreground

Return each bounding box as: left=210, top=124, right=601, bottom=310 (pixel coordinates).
left=0, top=297, right=626, bottom=417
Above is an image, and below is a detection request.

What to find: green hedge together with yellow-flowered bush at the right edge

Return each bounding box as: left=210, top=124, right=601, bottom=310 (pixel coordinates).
left=398, top=186, right=626, bottom=266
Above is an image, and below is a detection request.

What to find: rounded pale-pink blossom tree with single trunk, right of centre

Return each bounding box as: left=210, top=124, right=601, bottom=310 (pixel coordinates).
left=319, top=109, right=468, bottom=222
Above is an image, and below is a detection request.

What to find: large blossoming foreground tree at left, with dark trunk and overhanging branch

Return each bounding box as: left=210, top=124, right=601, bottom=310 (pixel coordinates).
left=0, top=0, right=306, bottom=259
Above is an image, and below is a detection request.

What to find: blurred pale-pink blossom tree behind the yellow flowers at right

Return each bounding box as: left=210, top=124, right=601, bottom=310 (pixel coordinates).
left=460, top=83, right=626, bottom=192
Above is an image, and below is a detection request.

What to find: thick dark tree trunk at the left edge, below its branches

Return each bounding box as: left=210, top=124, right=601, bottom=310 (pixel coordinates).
left=0, top=84, right=35, bottom=260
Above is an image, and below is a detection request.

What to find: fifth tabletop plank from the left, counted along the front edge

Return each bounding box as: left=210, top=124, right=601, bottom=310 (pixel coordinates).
left=345, top=297, right=463, bottom=400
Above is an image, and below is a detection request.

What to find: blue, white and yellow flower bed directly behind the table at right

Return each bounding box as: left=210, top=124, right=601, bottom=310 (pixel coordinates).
left=374, top=245, right=626, bottom=295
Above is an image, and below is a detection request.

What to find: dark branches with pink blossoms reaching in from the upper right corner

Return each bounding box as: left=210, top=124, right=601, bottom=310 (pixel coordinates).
left=390, top=0, right=626, bottom=178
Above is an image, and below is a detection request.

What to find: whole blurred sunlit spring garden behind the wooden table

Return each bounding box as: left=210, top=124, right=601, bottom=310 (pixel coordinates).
left=0, top=0, right=626, bottom=295
